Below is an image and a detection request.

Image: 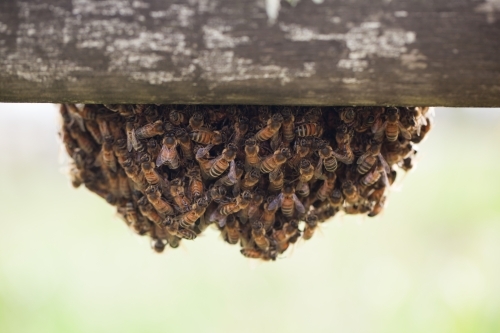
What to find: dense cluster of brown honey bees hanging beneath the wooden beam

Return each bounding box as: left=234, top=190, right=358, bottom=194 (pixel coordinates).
left=60, top=104, right=431, bottom=260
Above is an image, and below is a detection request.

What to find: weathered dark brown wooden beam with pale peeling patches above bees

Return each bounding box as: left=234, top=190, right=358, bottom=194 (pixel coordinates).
left=0, top=0, right=500, bottom=106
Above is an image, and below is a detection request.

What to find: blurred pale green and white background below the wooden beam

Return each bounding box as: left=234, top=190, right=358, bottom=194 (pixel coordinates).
left=0, top=104, right=500, bottom=333
